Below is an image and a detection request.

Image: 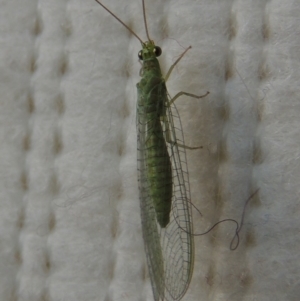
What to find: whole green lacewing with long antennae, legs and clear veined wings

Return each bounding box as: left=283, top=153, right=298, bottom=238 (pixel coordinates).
left=95, top=0, right=208, bottom=301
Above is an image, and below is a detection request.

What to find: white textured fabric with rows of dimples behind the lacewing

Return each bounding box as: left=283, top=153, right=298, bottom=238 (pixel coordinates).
left=0, top=0, right=300, bottom=301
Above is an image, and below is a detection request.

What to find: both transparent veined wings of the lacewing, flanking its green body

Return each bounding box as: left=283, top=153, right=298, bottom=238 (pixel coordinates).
left=137, top=85, right=194, bottom=301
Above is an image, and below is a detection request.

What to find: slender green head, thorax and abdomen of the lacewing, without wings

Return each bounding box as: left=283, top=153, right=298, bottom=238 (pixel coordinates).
left=137, top=43, right=173, bottom=228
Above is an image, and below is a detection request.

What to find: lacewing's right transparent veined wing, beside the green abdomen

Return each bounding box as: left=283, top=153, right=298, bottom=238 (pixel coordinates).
left=161, top=94, right=194, bottom=300
